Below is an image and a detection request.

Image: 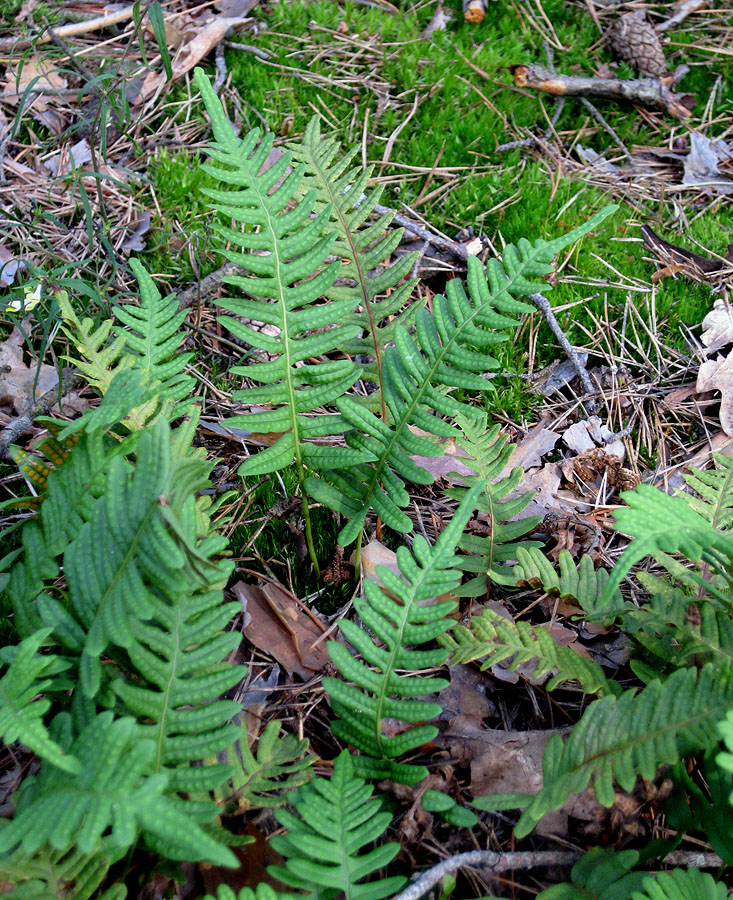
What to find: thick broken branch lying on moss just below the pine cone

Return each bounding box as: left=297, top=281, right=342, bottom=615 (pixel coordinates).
left=509, top=65, right=691, bottom=119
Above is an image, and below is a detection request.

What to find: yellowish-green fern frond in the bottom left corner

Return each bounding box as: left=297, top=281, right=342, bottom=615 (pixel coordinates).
left=0, top=848, right=127, bottom=900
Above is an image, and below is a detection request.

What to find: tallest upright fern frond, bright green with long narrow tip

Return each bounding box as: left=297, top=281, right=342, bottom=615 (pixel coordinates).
left=196, top=69, right=370, bottom=482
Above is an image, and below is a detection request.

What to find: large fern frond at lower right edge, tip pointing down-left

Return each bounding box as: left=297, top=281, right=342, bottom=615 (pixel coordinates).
left=516, top=664, right=733, bottom=837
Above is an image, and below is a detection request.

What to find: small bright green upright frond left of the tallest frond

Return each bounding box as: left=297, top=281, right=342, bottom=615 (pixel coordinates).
left=113, top=259, right=195, bottom=400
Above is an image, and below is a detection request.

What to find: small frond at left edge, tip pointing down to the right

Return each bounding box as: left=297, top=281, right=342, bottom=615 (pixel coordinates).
left=0, top=628, right=81, bottom=772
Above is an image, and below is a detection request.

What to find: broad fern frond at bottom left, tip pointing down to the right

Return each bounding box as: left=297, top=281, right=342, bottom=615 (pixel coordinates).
left=0, top=712, right=238, bottom=867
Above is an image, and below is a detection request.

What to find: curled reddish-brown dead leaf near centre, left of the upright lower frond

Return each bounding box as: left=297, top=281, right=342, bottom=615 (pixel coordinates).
left=232, top=581, right=329, bottom=680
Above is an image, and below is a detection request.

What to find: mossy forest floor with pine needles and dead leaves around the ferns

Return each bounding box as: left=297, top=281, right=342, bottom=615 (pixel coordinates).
left=0, top=0, right=733, bottom=897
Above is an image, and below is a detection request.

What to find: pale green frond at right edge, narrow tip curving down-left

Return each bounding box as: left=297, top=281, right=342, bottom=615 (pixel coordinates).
left=604, top=484, right=733, bottom=601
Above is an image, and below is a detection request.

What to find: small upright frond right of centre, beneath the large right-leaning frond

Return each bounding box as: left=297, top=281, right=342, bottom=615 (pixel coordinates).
left=445, top=415, right=541, bottom=597
